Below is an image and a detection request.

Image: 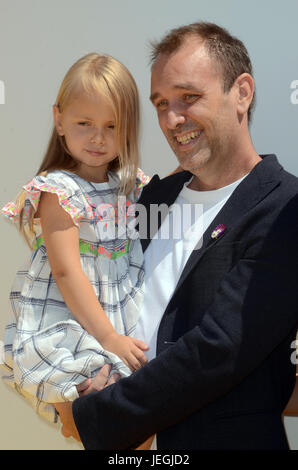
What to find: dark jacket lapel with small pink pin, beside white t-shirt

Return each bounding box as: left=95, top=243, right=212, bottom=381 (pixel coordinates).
left=168, top=155, right=282, bottom=297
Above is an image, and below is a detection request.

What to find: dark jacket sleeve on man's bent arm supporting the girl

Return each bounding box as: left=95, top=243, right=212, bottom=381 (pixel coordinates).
left=73, top=197, right=298, bottom=450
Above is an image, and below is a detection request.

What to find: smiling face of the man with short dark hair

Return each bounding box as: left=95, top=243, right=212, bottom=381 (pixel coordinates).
left=150, top=38, right=237, bottom=173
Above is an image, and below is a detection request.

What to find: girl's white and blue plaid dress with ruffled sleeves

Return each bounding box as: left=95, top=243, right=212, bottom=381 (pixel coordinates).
left=2, top=170, right=148, bottom=421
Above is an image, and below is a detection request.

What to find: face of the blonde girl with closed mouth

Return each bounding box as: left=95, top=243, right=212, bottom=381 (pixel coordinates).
left=53, top=92, right=118, bottom=182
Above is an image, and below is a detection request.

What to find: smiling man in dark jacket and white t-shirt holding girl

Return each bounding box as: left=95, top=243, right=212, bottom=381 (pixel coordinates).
left=56, top=23, right=298, bottom=450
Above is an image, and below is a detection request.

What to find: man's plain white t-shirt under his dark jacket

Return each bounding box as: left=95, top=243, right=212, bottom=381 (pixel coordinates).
left=135, top=176, right=245, bottom=361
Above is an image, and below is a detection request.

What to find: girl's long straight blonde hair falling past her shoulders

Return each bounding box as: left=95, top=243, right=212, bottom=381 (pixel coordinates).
left=16, top=52, right=140, bottom=246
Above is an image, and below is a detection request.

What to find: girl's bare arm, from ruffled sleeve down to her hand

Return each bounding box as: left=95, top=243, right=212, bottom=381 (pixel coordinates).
left=38, top=192, right=148, bottom=370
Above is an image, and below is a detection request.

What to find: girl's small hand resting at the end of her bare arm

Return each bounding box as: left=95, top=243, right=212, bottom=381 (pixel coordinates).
left=101, top=332, right=149, bottom=371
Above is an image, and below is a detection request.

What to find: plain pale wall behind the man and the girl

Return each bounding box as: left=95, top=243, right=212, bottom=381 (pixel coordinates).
left=0, top=0, right=298, bottom=449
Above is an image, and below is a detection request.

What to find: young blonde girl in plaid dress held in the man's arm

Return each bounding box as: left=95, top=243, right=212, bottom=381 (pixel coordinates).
left=2, top=53, right=148, bottom=421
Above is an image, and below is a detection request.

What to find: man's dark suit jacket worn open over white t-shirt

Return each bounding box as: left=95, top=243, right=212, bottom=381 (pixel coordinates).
left=73, top=155, right=298, bottom=450
